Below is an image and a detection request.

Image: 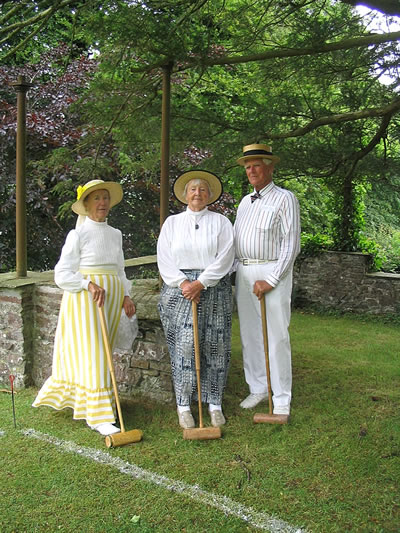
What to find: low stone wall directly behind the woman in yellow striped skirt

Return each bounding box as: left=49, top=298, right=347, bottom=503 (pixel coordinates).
left=0, top=272, right=174, bottom=402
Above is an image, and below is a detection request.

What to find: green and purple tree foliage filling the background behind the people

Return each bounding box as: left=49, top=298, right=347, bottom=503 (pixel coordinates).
left=0, top=0, right=400, bottom=268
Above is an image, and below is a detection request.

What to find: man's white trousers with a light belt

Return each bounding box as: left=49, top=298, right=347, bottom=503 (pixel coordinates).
left=235, top=263, right=293, bottom=407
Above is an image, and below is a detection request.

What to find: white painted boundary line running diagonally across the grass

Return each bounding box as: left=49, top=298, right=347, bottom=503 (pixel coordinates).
left=13, top=429, right=306, bottom=533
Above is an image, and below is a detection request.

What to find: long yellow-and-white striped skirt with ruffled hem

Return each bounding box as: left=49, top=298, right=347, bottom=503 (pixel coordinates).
left=32, top=273, right=124, bottom=426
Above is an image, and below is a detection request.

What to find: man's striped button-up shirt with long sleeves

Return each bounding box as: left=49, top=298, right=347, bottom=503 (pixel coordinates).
left=234, top=182, right=300, bottom=287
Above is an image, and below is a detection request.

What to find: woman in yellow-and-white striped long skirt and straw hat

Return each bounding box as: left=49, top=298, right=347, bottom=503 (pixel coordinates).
left=33, top=180, right=135, bottom=435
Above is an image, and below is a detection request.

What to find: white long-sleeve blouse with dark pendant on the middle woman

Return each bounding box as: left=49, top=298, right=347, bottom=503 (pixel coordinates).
left=157, top=207, right=235, bottom=288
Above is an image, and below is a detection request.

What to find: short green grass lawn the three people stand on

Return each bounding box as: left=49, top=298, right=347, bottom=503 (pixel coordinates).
left=0, top=312, right=400, bottom=533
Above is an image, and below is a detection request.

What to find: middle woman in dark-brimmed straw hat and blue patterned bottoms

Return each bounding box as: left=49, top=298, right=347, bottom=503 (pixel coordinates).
left=157, top=170, right=234, bottom=428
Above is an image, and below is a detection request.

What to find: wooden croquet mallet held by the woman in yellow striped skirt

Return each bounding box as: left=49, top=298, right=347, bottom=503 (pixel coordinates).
left=99, top=306, right=143, bottom=448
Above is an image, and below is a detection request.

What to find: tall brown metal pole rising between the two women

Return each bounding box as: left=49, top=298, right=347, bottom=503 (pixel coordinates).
left=160, top=63, right=172, bottom=228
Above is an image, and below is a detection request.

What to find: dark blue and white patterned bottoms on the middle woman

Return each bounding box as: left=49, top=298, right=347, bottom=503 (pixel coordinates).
left=158, top=270, right=232, bottom=406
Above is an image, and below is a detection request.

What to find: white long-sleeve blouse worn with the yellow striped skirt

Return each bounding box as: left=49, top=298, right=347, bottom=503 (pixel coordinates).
left=54, top=217, right=130, bottom=296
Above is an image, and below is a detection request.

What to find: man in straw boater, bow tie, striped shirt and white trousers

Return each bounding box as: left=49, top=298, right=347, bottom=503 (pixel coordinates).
left=234, top=144, right=300, bottom=415
